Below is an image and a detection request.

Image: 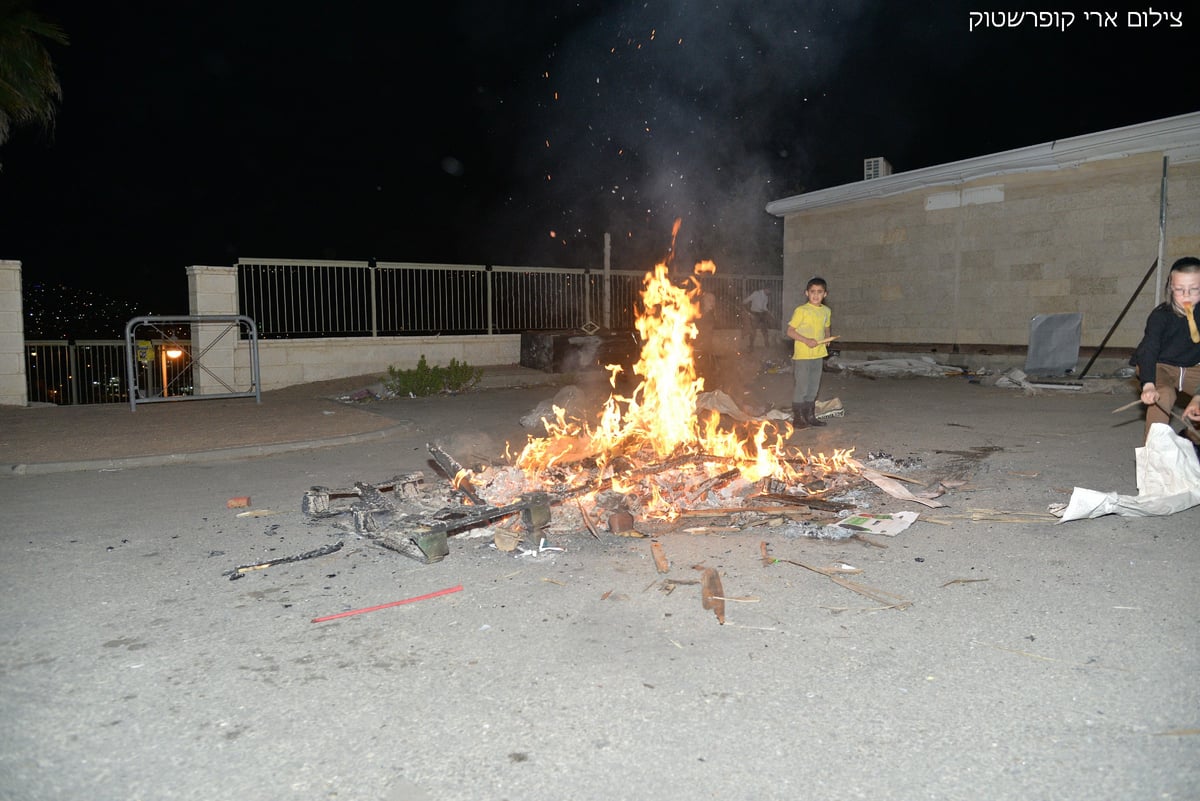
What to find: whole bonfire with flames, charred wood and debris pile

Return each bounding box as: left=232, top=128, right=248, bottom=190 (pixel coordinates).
left=295, top=256, right=943, bottom=568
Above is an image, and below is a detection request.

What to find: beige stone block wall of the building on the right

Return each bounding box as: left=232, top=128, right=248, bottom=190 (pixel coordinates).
left=768, top=115, right=1200, bottom=366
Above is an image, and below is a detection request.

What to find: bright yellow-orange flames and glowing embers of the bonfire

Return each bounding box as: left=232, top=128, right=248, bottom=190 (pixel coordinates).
left=516, top=244, right=857, bottom=519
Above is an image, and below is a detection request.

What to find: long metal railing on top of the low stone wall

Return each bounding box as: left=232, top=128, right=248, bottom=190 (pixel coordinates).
left=238, top=259, right=782, bottom=338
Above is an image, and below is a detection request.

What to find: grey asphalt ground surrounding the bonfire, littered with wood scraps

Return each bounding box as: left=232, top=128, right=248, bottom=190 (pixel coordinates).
left=0, top=362, right=1200, bottom=801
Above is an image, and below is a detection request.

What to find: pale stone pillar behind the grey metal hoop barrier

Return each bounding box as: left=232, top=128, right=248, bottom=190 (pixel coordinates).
left=187, top=266, right=238, bottom=395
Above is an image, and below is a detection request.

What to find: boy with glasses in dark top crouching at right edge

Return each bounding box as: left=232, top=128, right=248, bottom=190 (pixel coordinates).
left=1132, top=255, right=1200, bottom=447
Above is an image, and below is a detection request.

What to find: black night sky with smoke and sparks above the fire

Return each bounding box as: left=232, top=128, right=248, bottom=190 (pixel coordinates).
left=0, top=0, right=1200, bottom=314
